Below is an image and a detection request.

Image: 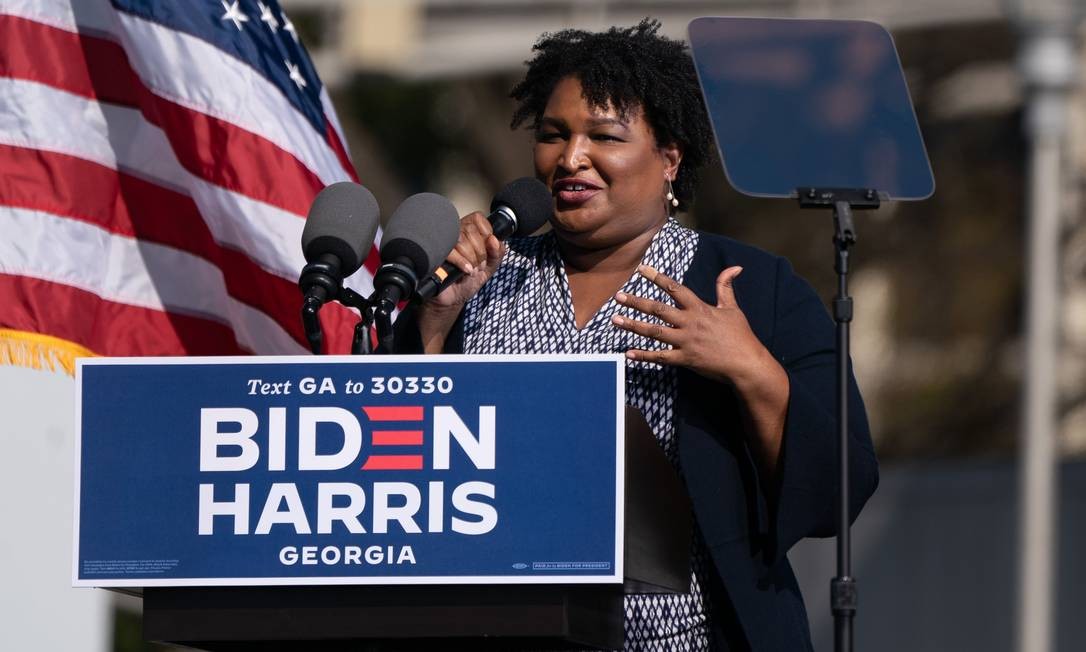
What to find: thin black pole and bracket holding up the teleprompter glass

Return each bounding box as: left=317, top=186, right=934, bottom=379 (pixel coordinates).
left=796, top=188, right=880, bottom=652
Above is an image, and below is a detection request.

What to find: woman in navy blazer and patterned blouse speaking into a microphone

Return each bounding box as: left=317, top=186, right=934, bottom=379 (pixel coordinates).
left=400, top=20, right=877, bottom=651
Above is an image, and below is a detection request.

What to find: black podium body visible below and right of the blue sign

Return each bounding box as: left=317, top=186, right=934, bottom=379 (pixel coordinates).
left=137, top=408, right=693, bottom=652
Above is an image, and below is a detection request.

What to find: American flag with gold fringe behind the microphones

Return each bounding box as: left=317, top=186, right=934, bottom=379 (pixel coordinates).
left=0, top=0, right=376, bottom=366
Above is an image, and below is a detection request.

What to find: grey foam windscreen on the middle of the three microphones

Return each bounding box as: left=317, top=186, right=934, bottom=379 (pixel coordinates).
left=381, top=192, right=460, bottom=278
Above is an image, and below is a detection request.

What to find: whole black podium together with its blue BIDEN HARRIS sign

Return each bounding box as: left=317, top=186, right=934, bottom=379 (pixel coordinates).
left=73, top=354, right=693, bottom=651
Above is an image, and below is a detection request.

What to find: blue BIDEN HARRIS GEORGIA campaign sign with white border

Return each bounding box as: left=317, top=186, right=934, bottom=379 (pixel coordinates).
left=73, top=355, right=624, bottom=587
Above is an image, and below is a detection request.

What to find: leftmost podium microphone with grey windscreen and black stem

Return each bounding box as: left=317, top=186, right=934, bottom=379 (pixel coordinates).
left=298, top=181, right=380, bottom=353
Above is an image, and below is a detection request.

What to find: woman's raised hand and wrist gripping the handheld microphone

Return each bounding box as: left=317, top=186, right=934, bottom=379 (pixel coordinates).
left=418, top=211, right=505, bottom=353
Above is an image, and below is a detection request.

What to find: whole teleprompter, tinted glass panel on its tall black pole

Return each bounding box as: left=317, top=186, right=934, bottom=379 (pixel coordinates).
left=689, top=16, right=935, bottom=651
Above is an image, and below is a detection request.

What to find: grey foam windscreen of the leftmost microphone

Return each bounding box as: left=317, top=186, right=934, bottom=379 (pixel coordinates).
left=302, top=181, right=381, bottom=277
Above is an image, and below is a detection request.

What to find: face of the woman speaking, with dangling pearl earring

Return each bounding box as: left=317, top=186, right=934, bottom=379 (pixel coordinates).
left=534, top=77, right=682, bottom=249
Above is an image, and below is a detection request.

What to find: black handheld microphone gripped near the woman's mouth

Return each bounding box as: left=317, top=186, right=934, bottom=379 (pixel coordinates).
left=416, top=177, right=554, bottom=299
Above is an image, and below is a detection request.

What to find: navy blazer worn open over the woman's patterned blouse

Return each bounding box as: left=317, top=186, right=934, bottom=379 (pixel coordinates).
left=396, top=233, right=879, bottom=652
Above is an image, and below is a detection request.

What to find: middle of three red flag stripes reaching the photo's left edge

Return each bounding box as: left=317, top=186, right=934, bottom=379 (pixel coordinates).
left=0, top=145, right=305, bottom=342
